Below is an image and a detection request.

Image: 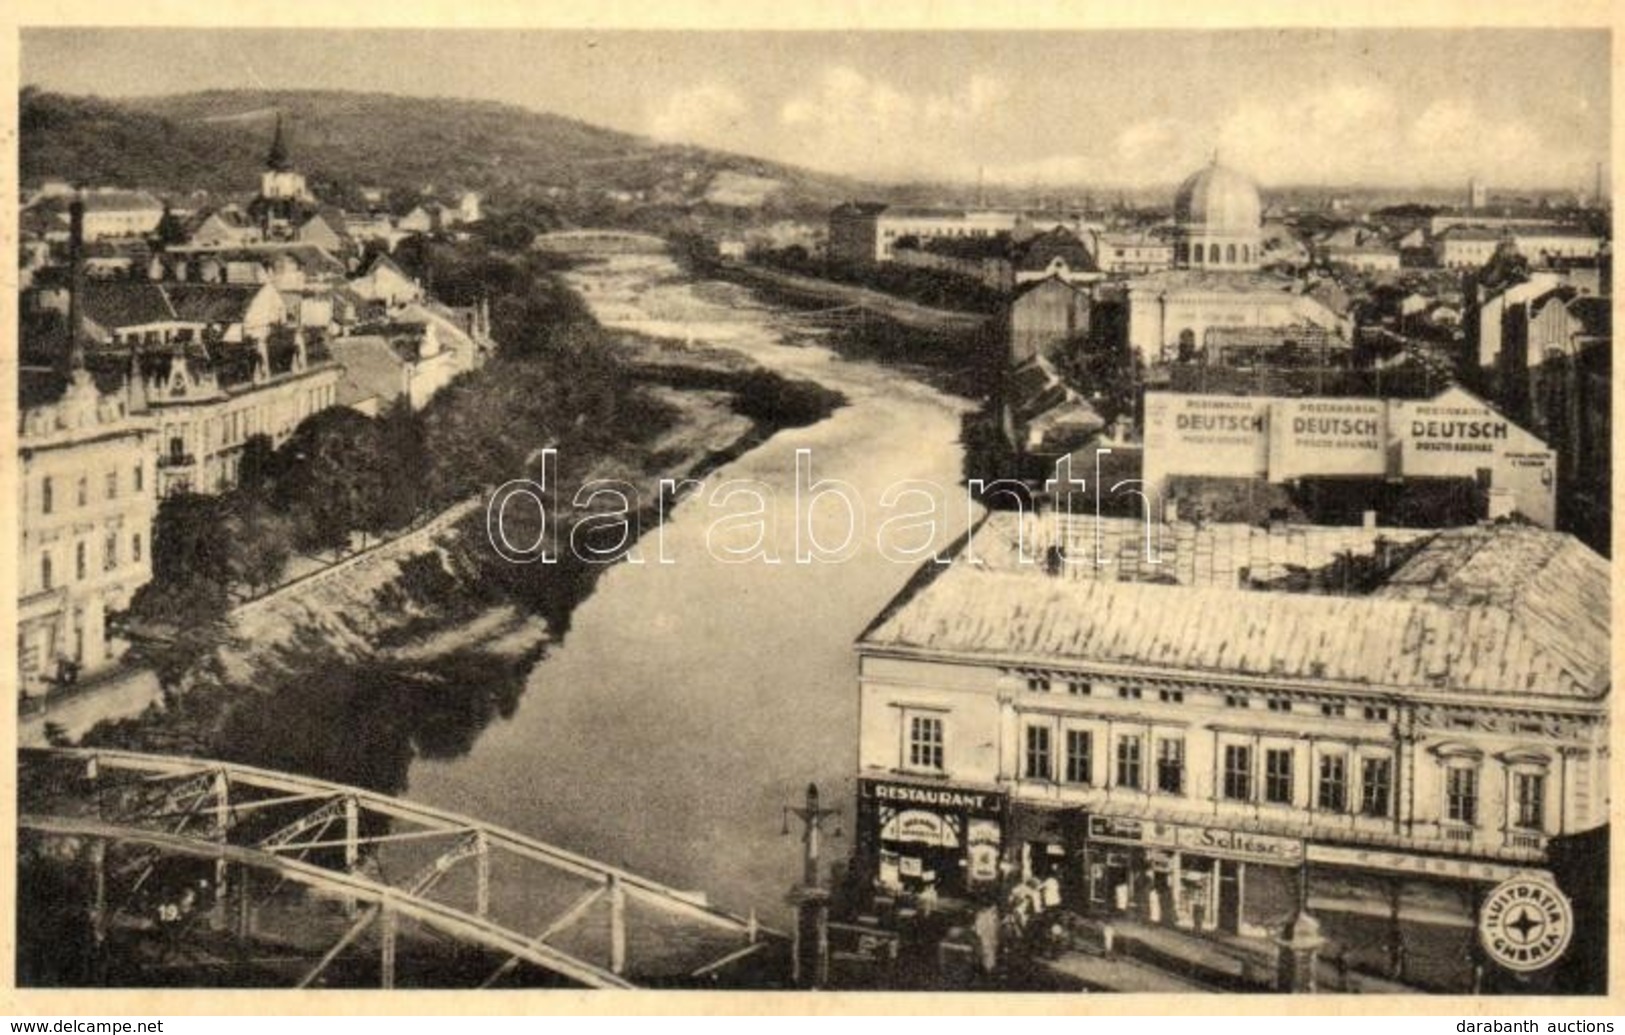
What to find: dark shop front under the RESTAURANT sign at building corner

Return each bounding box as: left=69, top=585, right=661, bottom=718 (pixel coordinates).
left=858, top=780, right=1006, bottom=897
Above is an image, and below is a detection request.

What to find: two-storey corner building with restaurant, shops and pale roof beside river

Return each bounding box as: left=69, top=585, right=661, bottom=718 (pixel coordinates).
left=858, top=513, right=1610, bottom=988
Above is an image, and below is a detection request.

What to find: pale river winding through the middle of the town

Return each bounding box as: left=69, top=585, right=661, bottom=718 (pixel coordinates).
left=406, top=255, right=970, bottom=923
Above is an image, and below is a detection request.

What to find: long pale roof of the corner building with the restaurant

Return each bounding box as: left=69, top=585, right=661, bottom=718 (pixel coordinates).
left=860, top=515, right=1609, bottom=699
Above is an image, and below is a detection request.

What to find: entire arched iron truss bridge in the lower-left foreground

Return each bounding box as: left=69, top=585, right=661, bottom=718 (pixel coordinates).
left=18, top=749, right=787, bottom=988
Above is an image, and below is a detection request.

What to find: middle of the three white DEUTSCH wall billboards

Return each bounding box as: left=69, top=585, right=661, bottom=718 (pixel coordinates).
left=1269, top=400, right=1388, bottom=481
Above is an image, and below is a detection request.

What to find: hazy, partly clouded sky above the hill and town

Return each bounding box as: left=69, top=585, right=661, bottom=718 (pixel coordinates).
left=21, top=28, right=1610, bottom=190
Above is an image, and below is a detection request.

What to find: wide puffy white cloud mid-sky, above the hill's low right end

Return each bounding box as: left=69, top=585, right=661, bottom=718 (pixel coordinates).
left=778, top=65, right=1011, bottom=179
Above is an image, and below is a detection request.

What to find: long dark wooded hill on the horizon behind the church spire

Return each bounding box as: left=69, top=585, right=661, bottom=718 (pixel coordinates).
left=20, top=88, right=871, bottom=214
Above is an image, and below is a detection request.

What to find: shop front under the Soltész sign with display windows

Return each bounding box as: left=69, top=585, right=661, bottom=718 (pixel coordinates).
left=1084, top=816, right=1303, bottom=934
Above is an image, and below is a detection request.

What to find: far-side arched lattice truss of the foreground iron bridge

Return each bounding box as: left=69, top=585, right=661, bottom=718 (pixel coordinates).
left=18, top=749, right=785, bottom=988
